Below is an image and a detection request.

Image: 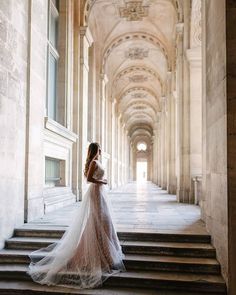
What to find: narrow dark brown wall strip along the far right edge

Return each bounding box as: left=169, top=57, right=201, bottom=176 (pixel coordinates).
left=226, top=1, right=236, bottom=295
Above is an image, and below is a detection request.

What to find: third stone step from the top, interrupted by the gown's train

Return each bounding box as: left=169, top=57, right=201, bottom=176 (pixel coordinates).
left=0, top=250, right=220, bottom=274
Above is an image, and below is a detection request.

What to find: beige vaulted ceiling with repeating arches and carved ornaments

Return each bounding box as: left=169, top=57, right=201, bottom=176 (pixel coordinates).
left=84, top=0, right=182, bottom=148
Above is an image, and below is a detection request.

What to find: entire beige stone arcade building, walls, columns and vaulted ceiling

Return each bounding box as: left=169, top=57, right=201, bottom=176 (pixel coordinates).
left=0, top=0, right=236, bottom=294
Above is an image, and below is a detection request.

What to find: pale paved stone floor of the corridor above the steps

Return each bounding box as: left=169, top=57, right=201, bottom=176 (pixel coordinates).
left=28, top=182, right=207, bottom=234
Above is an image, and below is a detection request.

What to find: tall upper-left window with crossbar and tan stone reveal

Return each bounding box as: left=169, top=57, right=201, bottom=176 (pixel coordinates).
left=47, top=0, right=67, bottom=125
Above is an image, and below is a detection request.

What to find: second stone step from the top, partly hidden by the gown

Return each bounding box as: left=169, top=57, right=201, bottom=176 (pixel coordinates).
left=6, top=237, right=216, bottom=258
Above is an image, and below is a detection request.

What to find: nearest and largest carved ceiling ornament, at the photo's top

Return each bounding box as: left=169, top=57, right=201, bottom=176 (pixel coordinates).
left=119, top=0, right=149, bottom=21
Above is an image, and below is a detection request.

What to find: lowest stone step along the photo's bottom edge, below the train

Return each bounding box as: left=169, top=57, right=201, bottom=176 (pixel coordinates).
left=0, top=281, right=224, bottom=295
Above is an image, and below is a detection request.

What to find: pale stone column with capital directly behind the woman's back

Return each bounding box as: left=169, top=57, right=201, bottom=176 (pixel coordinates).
left=79, top=27, right=93, bottom=199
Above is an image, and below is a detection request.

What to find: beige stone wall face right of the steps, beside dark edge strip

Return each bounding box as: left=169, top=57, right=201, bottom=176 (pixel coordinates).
left=202, top=0, right=228, bottom=280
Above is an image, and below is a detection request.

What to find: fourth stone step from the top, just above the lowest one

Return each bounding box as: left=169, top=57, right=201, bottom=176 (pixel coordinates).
left=0, top=264, right=226, bottom=295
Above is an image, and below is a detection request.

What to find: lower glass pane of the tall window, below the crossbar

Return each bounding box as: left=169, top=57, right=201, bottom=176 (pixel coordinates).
left=48, top=53, right=57, bottom=120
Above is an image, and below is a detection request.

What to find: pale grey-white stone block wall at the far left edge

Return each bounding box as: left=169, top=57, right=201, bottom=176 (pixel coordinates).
left=0, top=0, right=29, bottom=248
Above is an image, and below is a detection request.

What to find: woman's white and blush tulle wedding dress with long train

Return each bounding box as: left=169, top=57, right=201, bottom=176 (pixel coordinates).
left=28, top=160, right=125, bottom=289
